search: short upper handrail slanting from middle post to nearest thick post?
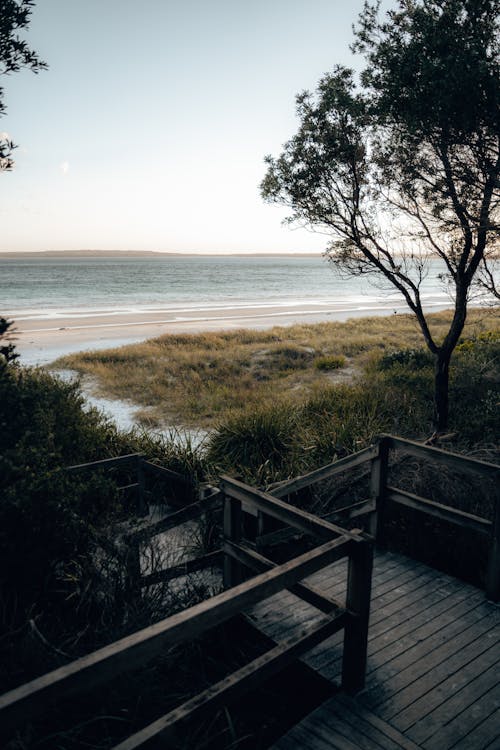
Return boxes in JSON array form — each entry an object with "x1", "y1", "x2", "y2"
[{"x1": 221, "y1": 475, "x2": 360, "y2": 541}]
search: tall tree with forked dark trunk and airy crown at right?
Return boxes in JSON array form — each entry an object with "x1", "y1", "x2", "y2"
[{"x1": 261, "y1": 0, "x2": 500, "y2": 433}]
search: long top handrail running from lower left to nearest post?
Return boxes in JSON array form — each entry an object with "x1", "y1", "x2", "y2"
[{"x1": 0, "y1": 535, "x2": 353, "y2": 728}]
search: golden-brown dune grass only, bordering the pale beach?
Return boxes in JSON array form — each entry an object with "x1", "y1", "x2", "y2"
[{"x1": 55, "y1": 310, "x2": 500, "y2": 428}]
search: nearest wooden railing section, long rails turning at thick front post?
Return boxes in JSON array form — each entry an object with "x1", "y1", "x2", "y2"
[{"x1": 0, "y1": 468, "x2": 373, "y2": 750}]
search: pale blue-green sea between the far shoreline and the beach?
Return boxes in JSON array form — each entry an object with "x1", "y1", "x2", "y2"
[{"x1": 0, "y1": 254, "x2": 450, "y2": 330}]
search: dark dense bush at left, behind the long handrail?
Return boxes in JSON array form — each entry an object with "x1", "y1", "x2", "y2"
[{"x1": 0, "y1": 357, "x2": 209, "y2": 691}]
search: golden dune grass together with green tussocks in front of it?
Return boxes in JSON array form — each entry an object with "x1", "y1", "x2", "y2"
[{"x1": 56, "y1": 309, "x2": 499, "y2": 483}]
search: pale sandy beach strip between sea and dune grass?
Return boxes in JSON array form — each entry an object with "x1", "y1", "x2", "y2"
[{"x1": 14, "y1": 301, "x2": 418, "y2": 365}]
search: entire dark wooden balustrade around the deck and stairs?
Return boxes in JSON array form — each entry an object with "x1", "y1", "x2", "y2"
[{"x1": 0, "y1": 435, "x2": 500, "y2": 750}]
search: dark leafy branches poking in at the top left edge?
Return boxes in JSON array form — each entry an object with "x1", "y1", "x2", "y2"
[{"x1": 0, "y1": 0, "x2": 47, "y2": 170}]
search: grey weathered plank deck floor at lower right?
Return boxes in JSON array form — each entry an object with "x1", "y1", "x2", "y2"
[{"x1": 251, "y1": 552, "x2": 500, "y2": 750}]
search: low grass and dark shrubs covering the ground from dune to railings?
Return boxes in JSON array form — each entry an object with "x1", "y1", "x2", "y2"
[{"x1": 0, "y1": 309, "x2": 500, "y2": 696}]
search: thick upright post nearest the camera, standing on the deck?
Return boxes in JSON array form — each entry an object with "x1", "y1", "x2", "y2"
[{"x1": 342, "y1": 538, "x2": 374, "y2": 693}]
